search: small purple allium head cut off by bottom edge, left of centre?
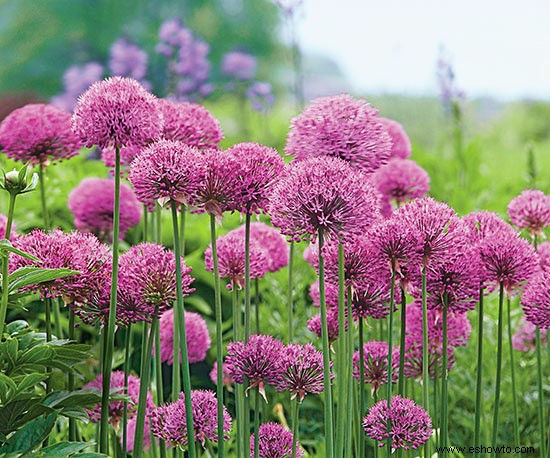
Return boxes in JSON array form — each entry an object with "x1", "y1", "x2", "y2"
[{"x1": 250, "y1": 422, "x2": 304, "y2": 458}]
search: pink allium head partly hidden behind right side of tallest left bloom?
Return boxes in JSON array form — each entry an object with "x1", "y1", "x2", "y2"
[{"x1": 159, "y1": 99, "x2": 223, "y2": 149}]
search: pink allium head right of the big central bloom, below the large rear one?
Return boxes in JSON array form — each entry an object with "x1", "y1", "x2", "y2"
[{"x1": 370, "y1": 159, "x2": 430, "y2": 207}]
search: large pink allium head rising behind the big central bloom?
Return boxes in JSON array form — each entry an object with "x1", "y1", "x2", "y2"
[{"x1": 285, "y1": 94, "x2": 392, "y2": 174}]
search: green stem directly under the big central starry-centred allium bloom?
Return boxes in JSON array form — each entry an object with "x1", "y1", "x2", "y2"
[{"x1": 318, "y1": 228, "x2": 334, "y2": 458}]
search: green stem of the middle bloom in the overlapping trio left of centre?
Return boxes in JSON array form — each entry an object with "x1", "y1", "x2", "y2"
[{"x1": 210, "y1": 215, "x2": 225, "y2": 457}]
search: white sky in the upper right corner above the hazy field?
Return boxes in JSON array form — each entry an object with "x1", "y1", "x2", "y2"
[{"x1": 298, "y1": 0, "x2": 550, "y2": 99}]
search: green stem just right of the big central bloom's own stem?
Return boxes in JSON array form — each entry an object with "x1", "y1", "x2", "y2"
[{"x1": 335, "y1": 242, "x2": 350, "y2": 456}]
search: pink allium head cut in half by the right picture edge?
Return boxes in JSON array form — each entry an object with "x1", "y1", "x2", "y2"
[{"x1": 521, "y1": 271, "x2": 550, "y2": 329}]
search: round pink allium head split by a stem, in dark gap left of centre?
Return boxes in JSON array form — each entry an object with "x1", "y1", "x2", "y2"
[{"x1": 160, "y1": 309, "x2": 211, "y2": 366}]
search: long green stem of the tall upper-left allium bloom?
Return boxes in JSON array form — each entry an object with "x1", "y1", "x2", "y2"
[{"x1": 99, "y1": 145, "x2": 120, "y2": 454}]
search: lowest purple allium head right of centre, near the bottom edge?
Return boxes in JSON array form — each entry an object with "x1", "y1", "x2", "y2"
[{"x1": 363, "y1": 395, "x2": 432, "y2": 450}]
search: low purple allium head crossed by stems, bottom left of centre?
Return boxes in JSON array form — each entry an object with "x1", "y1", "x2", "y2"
[{"x1": 150, "y1": 390, "x2": 231, "y2": 448}]
